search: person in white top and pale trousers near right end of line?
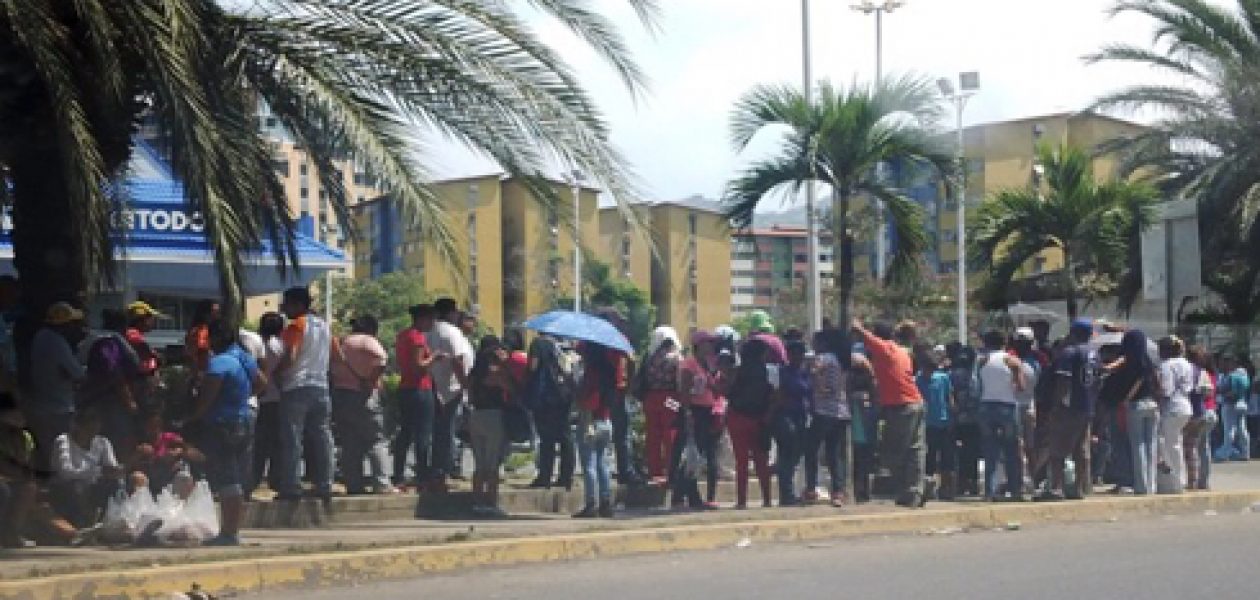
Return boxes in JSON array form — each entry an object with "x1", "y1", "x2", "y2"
[{"x1": 1157, "y1": 337, "x2": 1197, "y2": 494}]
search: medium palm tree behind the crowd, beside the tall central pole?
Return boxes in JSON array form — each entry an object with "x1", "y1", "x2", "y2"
[{"x1": 723, "y1": 77, "x2": 953, "y2": 323}]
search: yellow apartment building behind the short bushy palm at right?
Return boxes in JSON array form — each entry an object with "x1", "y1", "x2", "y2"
[{"x1": 936, "y1": 112, "x2": 1144, "y2": 275}]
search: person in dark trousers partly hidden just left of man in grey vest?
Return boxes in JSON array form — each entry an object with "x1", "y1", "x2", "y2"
[{"x1": 244, "y1": 313, "x2": 285, "y2": 499}]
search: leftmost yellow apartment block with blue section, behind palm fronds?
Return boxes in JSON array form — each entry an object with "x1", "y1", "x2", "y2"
[{"x1": 353, "y1": 174, "x2": 504, "y2": 332}]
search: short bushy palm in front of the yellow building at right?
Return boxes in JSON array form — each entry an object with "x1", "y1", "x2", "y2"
[{"x1": 968, "y1": 144, "x2": 1157, "y2": 319}]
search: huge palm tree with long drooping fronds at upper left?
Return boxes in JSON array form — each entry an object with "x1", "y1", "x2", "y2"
[{"x1": 0, "y1": 0, "x2": 656, "y2": 309}]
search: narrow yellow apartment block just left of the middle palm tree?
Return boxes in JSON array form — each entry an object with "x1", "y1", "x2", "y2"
[{"x1": 651, "y1": 198, "x2": 731, "y2": 335}]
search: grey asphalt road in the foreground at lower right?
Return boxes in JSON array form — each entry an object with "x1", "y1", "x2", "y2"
[{"x1": 252, "y1": 513, "x2": 1260, "y2": 600}]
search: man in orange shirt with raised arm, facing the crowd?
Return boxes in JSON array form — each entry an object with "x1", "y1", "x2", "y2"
[{"x1": 853, "y1": 319, "x2": 927, "y2": 508}]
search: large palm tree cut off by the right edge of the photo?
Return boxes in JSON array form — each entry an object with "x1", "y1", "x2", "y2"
[{"x1": 1087, "y1": 0, "x2": 1260, "y2": 324}]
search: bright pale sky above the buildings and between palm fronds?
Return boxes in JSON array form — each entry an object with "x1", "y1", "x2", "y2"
[{"x1": 440, "y1": 0, "x2": 1189, "y2": 206}]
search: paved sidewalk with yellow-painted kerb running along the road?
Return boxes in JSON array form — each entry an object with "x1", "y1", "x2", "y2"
[{"x1": 7, "y1": 464, "x2": 1260, "y2": 599}]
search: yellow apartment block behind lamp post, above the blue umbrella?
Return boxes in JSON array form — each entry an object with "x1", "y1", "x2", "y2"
[{"x1": 501, "y1": 178, "x2": 600, "y2": 323}]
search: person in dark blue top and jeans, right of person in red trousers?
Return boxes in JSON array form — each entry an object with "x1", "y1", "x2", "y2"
[{"x1": 770, "y1": 340, "x2": 816, "y2": 507}]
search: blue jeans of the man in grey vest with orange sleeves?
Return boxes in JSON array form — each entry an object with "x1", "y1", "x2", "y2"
[{"x1": 280, "y1": 386, "x2": 333, "y2": 498}]
